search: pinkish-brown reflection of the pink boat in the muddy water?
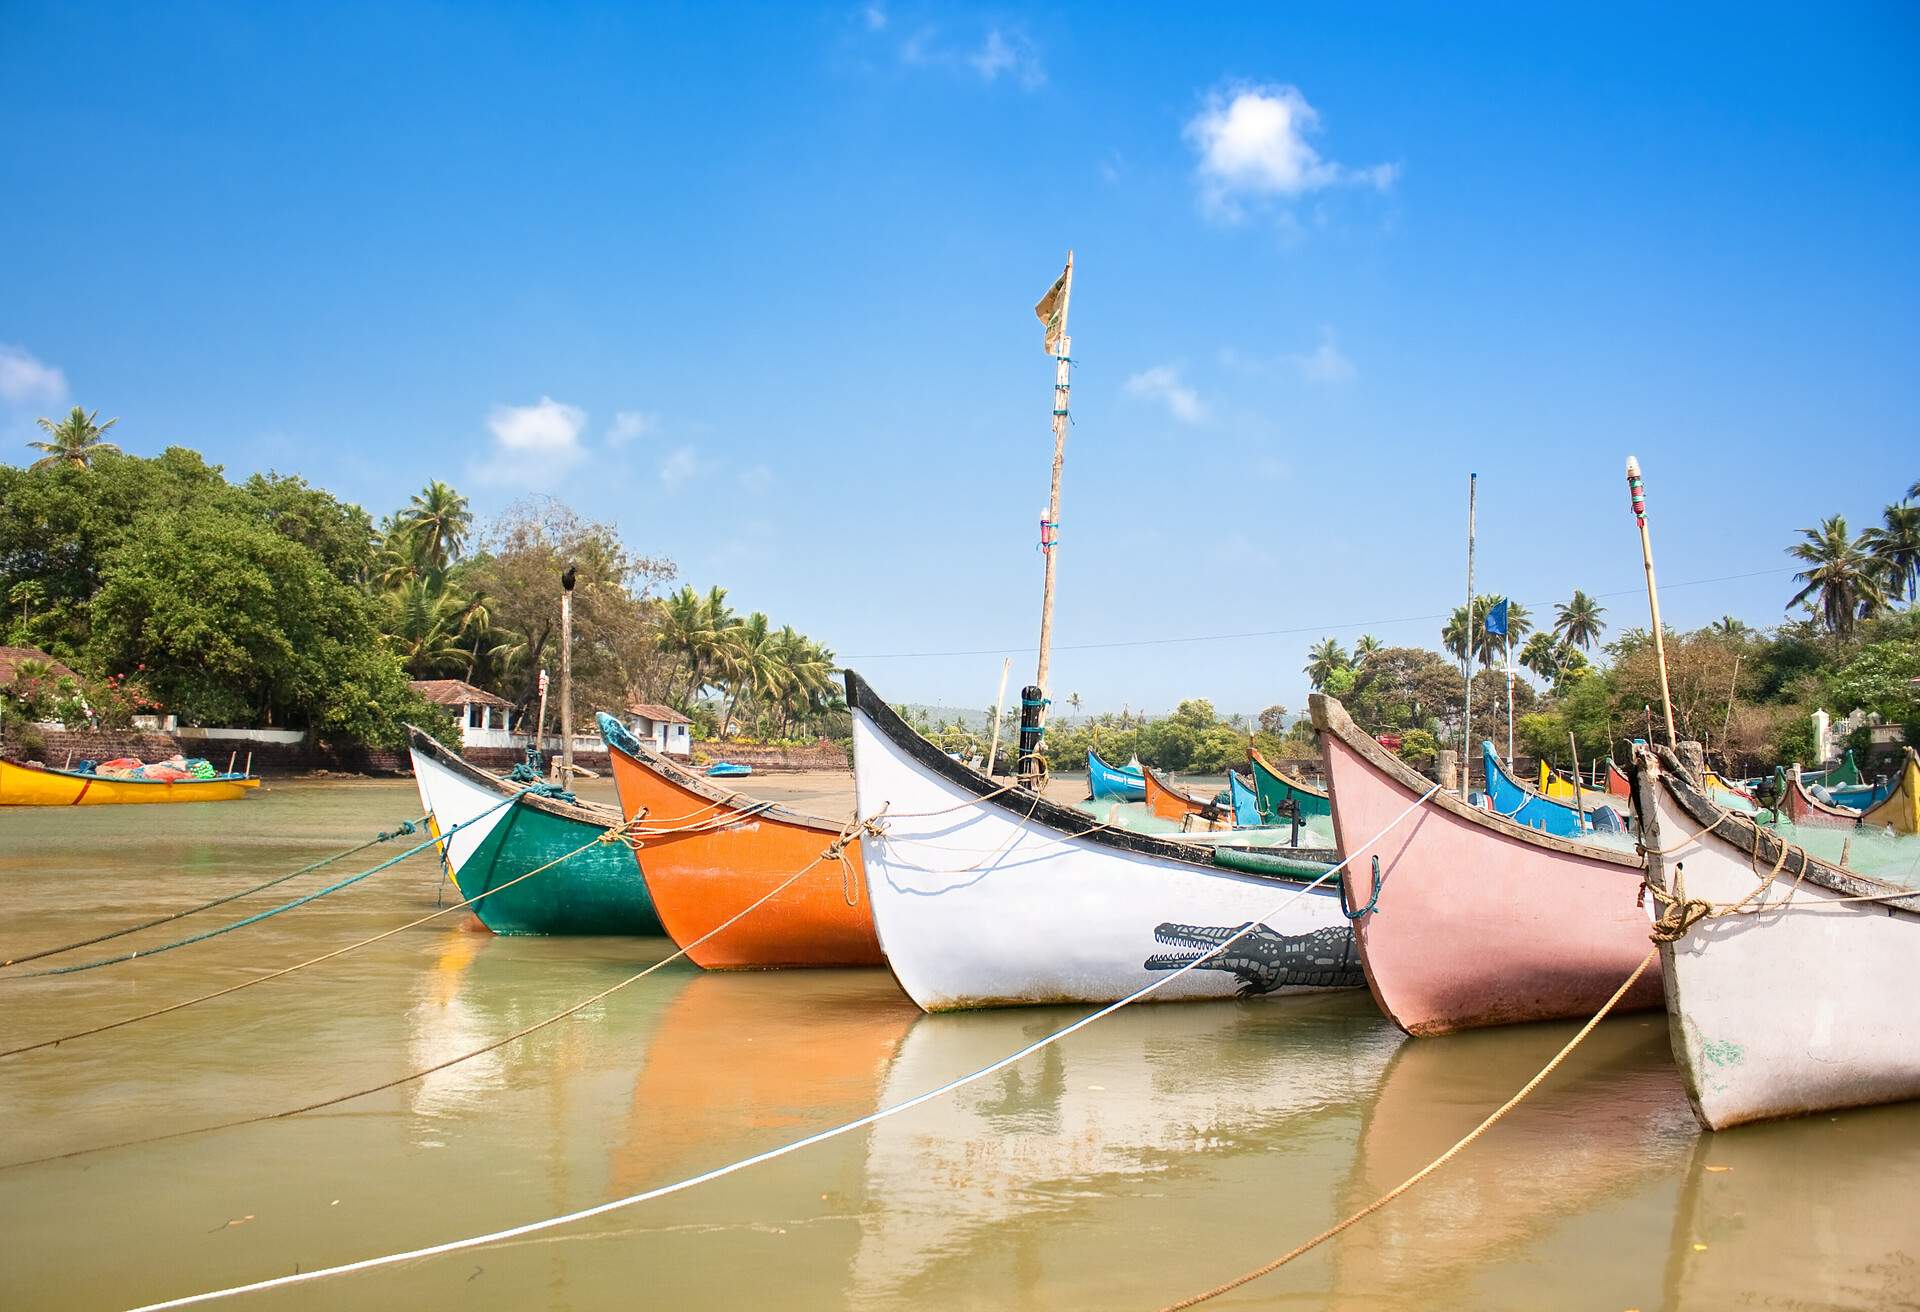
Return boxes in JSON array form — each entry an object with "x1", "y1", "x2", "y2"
[{"x1": 1328, "y1": 1016, "x2": 1695, "y2": 1308}]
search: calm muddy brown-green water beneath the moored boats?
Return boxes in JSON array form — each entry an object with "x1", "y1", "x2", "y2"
[{"x1": 0, "y1": 780, "x2": 1920, "y2": 1310}]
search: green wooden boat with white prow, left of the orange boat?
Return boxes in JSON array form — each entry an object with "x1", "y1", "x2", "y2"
[{"x1": 407, "y1": 724, "x2": 660, "y2": 935}]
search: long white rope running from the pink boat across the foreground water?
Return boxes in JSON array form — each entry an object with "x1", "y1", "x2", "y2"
[{"x1": 123, "y1": 784, "x2": 1443, "y2": 1312}]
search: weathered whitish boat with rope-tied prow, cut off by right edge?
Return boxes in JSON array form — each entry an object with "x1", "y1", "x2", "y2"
[{"x1": 1634, "y1": 747, "x2": 1920, "y2": 1130}]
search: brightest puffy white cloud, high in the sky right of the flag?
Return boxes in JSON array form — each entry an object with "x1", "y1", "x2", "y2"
[{"x1": 1187, "y1": 85, "x2": 1398, "y2": 219}]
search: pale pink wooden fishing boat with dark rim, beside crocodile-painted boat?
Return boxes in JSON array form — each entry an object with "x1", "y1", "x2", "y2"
[{"x1": 1309, "y1": 693, "x2": 1663, "y2": 1035}]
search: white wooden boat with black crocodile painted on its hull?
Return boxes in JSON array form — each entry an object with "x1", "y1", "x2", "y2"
[{"x1": 847, "y1": 670, "x2": 1361, "y2": 1012}]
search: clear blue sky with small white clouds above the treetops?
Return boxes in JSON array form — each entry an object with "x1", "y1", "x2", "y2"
[{"x1": 0, "y1": 0, "x2": 1920, "y2": 711}]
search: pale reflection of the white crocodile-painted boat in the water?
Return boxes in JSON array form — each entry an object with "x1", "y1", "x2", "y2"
[{"x1": 847, "y1": 995, "x2": 1402, "y2": 1308}]
